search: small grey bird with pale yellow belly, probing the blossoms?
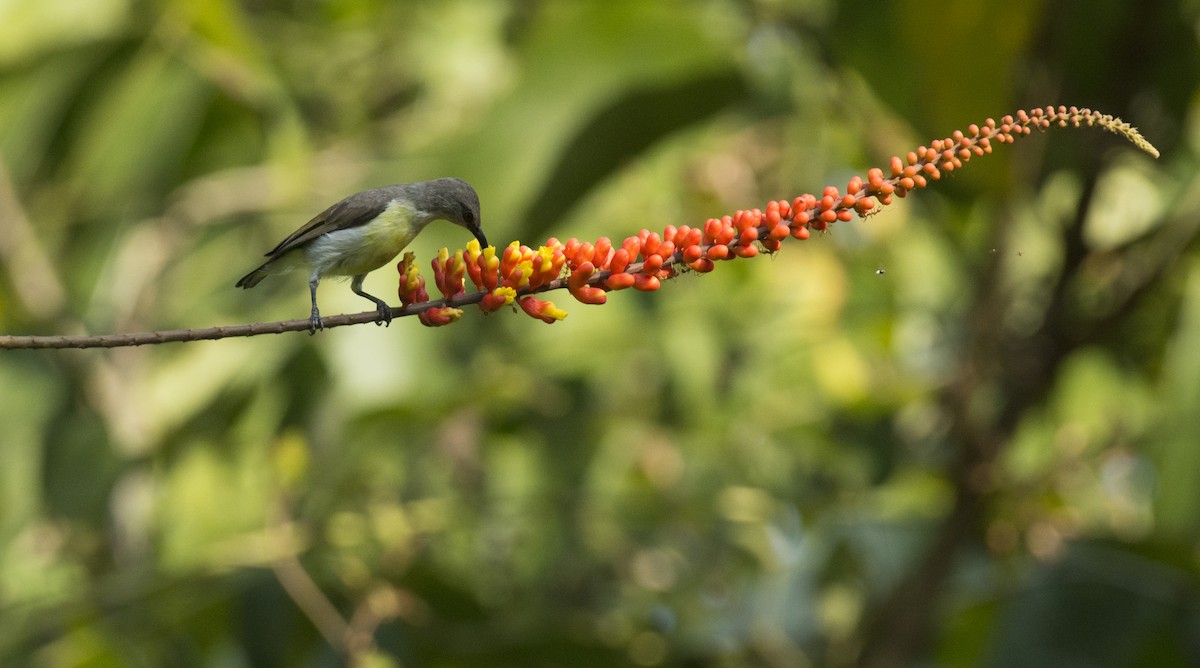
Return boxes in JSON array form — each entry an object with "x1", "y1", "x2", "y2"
[{"x1": 236, "y1": 177, "x2": 487, "y2": 335}]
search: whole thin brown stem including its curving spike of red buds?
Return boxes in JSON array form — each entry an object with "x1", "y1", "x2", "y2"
[{"x1": 0, "y1": 107, "x2": 1158, "y2": 349}]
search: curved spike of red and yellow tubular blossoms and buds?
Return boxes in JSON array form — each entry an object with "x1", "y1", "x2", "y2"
[{"x1": 400, "y1": 107, "x2": 1158, "y2": 325}]
